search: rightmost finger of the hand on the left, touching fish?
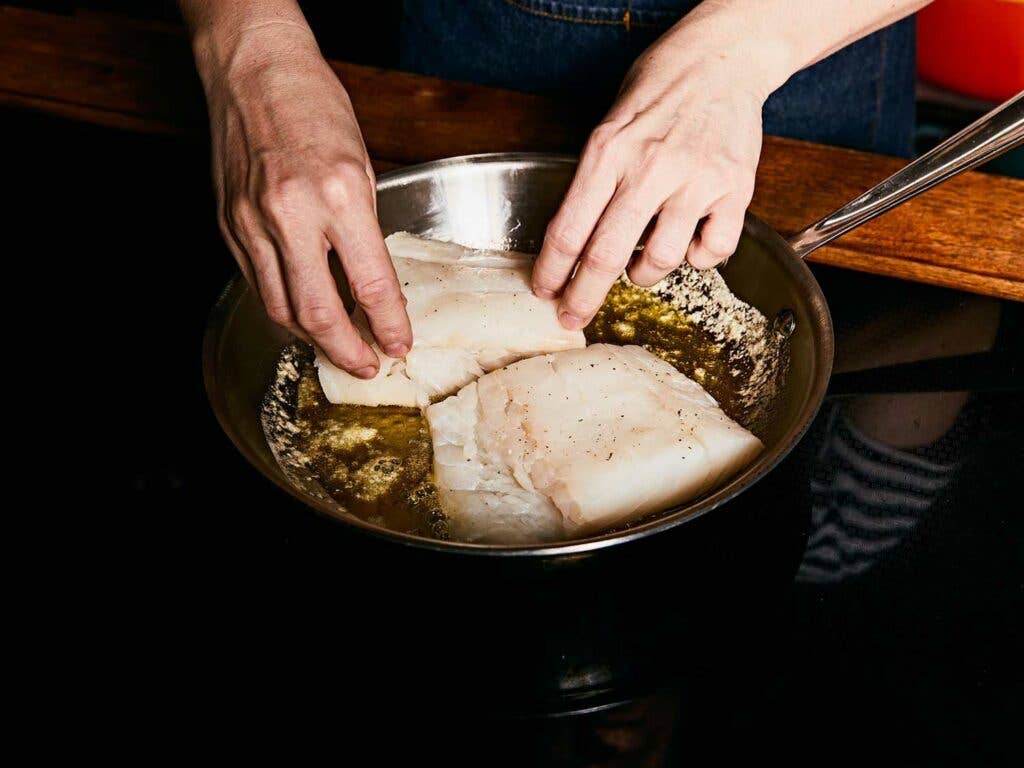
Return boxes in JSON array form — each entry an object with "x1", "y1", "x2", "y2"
[{"x1": 328, "y1": 200, "x2": 413, "y2": 357}]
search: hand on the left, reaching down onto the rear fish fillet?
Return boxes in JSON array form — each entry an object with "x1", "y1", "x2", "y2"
[{"x1": 204, "y1": 32, "x2": 413, "y2": 378}]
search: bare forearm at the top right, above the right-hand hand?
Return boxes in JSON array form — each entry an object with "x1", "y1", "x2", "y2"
[{"x1": 666, "y1": 0, "x2": 930, "y2": 96}]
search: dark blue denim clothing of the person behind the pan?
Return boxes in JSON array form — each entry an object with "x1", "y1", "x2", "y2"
[{"x1": 401, "y1": 0, "x2": 914, "y2": 156}]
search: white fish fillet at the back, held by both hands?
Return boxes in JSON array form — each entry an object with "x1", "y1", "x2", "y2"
[{"x1": 316, "y1": 232, "x2": 586, "y2": 408}]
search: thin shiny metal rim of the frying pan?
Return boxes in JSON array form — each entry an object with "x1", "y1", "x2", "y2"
[{"x1": 203, "y1": 152, "x2": 835, "y2": 559}]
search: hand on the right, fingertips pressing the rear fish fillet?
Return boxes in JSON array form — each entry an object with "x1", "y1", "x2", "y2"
[{"x1": 534, "y1": 25, "x2": 770, "y2": 329}]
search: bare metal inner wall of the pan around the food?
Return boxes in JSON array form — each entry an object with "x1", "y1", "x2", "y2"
[{"x1": 205, "y1": 156, "x2": 831, "y2": 551}]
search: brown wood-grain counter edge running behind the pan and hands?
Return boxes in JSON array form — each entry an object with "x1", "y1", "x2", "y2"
[{"x1": 0, "y1": 5, "x2": 1024, "y2": 300}]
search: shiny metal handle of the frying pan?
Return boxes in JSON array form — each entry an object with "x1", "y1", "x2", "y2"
[{"x1": 790, "y1": 91, "x2": 1024, "y2": 258}]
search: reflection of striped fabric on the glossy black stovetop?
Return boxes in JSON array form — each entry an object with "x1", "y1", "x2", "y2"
[{"x1": 797, "y1": 403, "x2": 964, "y2": 585}]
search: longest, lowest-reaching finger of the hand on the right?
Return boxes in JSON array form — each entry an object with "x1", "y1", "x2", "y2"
[{"x1": 558, "y1": 187, "x2": 657, "y2": 330}]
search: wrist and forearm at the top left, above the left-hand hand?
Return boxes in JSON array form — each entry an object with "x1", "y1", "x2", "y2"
[{"x1": 179, "y1": 0, "x2": 318, "y2": 89}]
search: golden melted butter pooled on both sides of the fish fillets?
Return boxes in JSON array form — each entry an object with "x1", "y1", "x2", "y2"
[{"x1": 294, "y1": 283, "x2": 744, "y2": 539}]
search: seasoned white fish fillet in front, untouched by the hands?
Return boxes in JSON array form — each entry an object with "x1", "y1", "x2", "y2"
[{"x1": 426, "y1": 344, "x2": 763, "y2": 544}]
